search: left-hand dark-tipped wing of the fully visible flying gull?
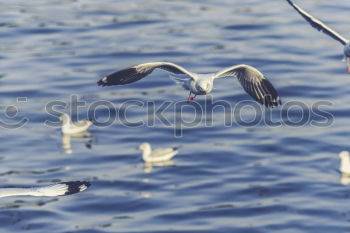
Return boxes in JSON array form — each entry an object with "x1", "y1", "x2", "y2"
[{"x1": 97, "y1": 62, "x2": 197, "y2": 86}]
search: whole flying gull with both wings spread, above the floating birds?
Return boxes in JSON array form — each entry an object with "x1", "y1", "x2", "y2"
[{"x1": 97, "y1": 62, "x2": 281, "y2": 107}]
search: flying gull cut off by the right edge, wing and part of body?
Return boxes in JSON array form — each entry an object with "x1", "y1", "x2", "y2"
[{"x1": 287, "y1": 0, "x2": 350, "y2": 73}]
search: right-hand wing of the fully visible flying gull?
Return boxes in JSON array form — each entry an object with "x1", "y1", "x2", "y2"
[{"x1": 214, "y1": 65, "x2": 281, "y2": 107}]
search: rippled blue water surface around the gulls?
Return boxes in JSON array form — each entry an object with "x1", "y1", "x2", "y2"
[{"x1": 0, "y1": 0, "x2": 350, "y2": 232}]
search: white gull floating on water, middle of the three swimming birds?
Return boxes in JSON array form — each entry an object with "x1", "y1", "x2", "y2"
[{"x1": 138, "y1": 142, "x2": 179, "y2": 163}]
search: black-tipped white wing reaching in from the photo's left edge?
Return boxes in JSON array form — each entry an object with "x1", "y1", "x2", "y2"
[{"x1": 0, "y1": 181, "x2": 91, "y2": 197}]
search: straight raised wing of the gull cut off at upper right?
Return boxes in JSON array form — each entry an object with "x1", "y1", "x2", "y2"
[{"x1": 287, "y1": 0, "x2": 348, "y2": 45}]
